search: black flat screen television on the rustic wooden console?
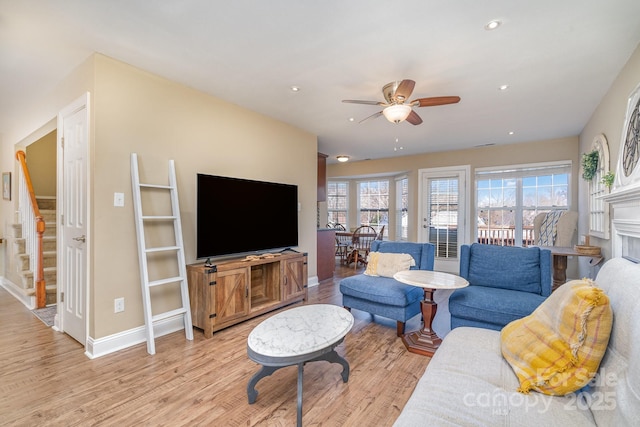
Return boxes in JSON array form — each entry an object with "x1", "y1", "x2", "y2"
[{"x1": 196, "y1": 173, "x2": 298, "y2": 258}]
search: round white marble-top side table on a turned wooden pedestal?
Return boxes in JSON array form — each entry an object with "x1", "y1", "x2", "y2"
[{"x1": 393, "y1": 270, "x2": 469, "y2": 356}]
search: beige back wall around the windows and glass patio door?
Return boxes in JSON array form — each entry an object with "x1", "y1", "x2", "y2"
[{"x1": 327, "y1": 137, "x2": 579, "y2": 241}]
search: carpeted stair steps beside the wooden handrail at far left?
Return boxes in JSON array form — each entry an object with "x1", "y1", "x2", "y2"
[{"x1": 13, "y1": 196, "x2": 57, "y2": 305}]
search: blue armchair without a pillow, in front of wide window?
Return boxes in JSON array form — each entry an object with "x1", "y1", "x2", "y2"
[{"x1": 449, "y1": 243, "x2": 551, "y2": 331}]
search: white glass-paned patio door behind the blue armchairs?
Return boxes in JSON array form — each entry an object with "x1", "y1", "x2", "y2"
[{"x1": 418, "y1": 166, "x2": 469, "y2": 274}]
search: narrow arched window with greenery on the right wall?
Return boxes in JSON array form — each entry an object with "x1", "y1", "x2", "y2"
[{"x1": 589, "y1": 134, "x2": 609, "y2": 239}]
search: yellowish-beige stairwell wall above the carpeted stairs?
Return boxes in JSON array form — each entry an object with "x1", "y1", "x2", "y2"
[{"x1": 26, "y1": 131, "x2": 57, "y2": 196}]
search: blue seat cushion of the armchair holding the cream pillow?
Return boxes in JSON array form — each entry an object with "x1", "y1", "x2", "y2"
[{"x1": 340, "y1": 274, "x2": 424, "y2": 307}]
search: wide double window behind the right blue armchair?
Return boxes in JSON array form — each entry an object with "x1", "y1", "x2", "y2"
[{"x1": 476, "y1": 162, "x2": 571, "y2": 246}]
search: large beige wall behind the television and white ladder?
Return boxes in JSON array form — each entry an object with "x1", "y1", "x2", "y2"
[{"x1": 2, "y1": 54, "x2": 317, "y2": 339}]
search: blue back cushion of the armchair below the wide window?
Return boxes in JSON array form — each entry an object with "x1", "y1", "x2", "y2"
[{"x1": 461, "y1": 244, "x2": 542, "y2": 295}]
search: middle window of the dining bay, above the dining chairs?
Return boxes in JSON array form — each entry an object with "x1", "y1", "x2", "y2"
[{"x1": 358, "y1": 180, "x2": 389, "y2": 231}]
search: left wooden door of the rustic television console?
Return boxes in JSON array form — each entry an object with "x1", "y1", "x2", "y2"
[{"x1": 212, "y1": 268, "x2": 250, "y2": 326}]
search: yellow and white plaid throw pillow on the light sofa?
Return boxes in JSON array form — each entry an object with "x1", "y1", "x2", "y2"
[{"x1": 500, "y1": 279, "x2": 613, "y2": 395}]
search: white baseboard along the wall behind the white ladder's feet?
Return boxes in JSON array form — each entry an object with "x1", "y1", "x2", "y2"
[{"x1": 84, "y1": 315, "x2": 184, "y2": 359}]
